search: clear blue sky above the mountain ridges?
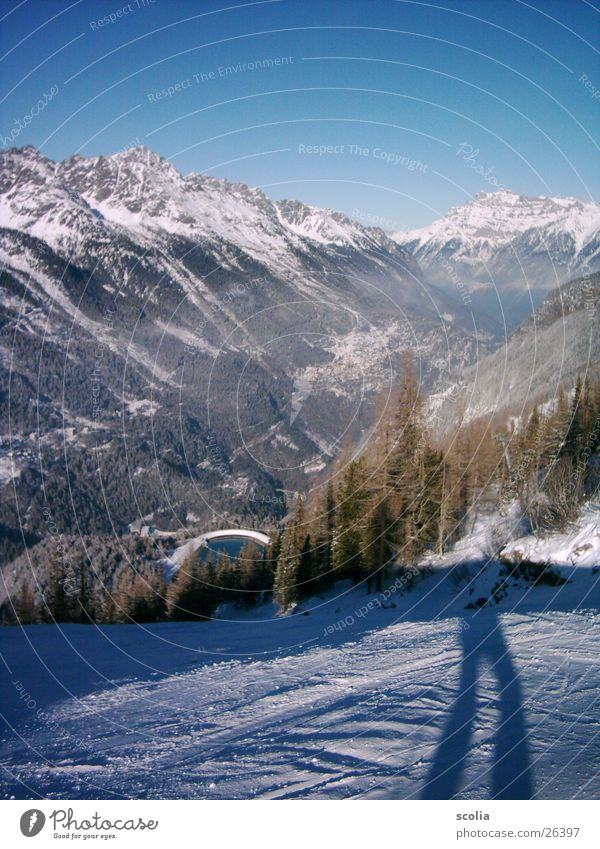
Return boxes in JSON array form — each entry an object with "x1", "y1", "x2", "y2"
[{"x1": 0, "y1": 0, "x2": 600, "y2": 229}]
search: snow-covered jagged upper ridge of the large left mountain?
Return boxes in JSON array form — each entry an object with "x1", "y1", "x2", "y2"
[{"x1": 0, "y1": 147, "x2": 414, "y2": 274}]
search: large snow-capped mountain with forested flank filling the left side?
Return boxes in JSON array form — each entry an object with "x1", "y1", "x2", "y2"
[{"x1": 0, "y1": 147, "x2": 496, "y2": 547}]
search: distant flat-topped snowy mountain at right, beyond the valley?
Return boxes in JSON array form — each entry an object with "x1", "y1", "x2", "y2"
[{"x1": 392, "y1": 190, "x2": 600, "y2": 330}]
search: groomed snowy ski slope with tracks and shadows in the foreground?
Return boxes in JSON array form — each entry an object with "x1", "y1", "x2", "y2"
[{"x1": 0, "y1": 504, "x2": 600, "y2": 799}]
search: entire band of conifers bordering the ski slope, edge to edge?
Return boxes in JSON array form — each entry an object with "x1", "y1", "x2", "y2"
[{"x1": 2, "y1": 357, "x2": 600, "y2": 623}]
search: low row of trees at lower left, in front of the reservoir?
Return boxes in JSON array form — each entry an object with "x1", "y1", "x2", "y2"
[{"x1": 0, "y1": 535, "x2": 277, "y2": 625}]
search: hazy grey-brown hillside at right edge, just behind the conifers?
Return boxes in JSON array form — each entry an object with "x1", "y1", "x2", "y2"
[{"x1": 430, "y1": 272, "x2": 600, "y2": 430}]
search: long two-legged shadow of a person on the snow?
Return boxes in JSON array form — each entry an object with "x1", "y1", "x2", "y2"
[{"x1": 421, "y1": 610, "x2": 533, "y2": 799}]
